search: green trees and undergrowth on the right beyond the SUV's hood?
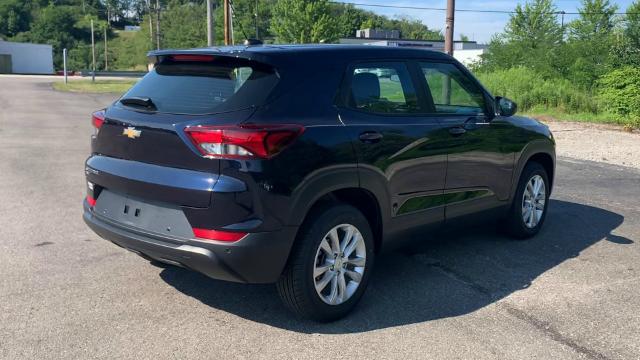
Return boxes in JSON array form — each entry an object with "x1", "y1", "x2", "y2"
[{"x1": 473, "y1": 0, "x2": 640, "y2": 126}]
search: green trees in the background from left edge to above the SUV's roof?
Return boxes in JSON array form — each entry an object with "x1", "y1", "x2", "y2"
[{"x1": 0, "y1": 0, "x2": 443, "y2": 70}]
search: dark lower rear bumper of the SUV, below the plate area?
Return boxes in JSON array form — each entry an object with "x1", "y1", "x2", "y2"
[{"x1": 83, "y1": 201, "x2": 297, "y2": 283}]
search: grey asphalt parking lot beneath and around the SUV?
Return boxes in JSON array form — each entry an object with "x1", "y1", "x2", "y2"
[{"x1": 0, "y1": 77, "x2": 640, "y2": 359}]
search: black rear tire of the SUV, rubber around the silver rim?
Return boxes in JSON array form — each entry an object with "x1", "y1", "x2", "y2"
[{"x1": 277, "y1": 204, "x2": 374, "y2": 322}]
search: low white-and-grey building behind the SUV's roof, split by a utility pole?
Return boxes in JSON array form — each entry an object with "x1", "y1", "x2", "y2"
[{"x1": 340, "y1": 29, "x2": 487, "y2": 65}]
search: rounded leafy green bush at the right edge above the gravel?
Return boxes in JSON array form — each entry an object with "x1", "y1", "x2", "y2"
[{"x1": 598, "y1": 66, "x2": 640, "y2": 122}]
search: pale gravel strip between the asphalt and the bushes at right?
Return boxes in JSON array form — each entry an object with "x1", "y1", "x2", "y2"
[{"x1": 544, "y1": 121, "x2": 640, "y2": 169}]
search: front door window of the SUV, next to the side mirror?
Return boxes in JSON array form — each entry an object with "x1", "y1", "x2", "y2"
[{"x1": 420, "y1": 63, "x2": 485, "y2": 115}]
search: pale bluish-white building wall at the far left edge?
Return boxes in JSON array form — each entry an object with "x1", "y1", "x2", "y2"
[{"x1": 0, "y1": 40, "x2": 53, "y2": 74}]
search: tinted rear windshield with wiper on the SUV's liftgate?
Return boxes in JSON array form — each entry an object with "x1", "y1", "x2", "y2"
[{"x1": 118, "y1": 57, "x2": 278, "y2": 115}]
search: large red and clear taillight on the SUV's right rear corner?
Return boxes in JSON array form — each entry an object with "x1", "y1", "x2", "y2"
[{"x1": 184, "y1": 125, "x2": 304, "y2": 159}]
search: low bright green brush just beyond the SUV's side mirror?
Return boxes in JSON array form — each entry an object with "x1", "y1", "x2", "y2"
[{"x1": 476, "y1": 67, "x2": 599, "y2": 113}]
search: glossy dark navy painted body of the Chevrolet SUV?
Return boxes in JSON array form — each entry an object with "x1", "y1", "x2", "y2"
[{"x1": 85, "y1": 45, "x2": 555, "y2": 282}]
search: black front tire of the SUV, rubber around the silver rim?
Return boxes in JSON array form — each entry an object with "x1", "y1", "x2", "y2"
[{"x1": 505, "y1": 162, "x2": 550, "y2": 239}]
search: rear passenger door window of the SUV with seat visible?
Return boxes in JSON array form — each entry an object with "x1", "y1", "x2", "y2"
[{"x1": 349, "y1": 63, "x2": 419, "y2": 114}]
